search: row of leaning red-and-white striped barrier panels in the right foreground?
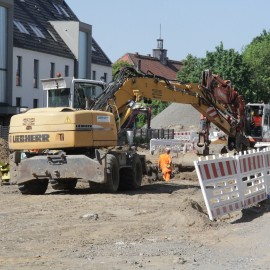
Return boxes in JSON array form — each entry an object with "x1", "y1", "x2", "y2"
[{"x1": 194, "y1": 150, "x2": 270, "y2": 220}]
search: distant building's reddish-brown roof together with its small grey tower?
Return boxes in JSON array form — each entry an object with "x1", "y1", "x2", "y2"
[{"x1": 117, "y1": 38, "x2": 182, "y2": 80}]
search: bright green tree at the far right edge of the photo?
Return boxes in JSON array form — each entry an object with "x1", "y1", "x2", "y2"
[{"x1": 243, "y1": 30, "x2": 270, "y2": 103}]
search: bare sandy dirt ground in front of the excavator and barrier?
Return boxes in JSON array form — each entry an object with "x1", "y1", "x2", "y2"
[{"x1": 0, "y1": 142, "x2": 270, "y2": 270}]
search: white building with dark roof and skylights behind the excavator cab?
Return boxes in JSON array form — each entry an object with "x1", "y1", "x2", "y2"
[{"x1": 0, "y1": 0, "x2": 112, "y2": 125}]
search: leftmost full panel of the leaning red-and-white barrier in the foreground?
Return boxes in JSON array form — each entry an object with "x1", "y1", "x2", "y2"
[{"x1": 194, "y1": 156, "x2": 243, "y2": 220}]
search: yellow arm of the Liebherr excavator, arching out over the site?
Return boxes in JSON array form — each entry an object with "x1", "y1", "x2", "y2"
[{"x1": 93, "y1": 68, "x2": 244, "y2": 151}]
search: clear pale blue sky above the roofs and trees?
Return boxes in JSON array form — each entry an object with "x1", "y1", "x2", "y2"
[{"x1": 66, "y1": 0, "x2": 270, "y2": 62}]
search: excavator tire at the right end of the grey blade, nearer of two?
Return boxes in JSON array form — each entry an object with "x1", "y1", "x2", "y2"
[{"x1": 104, "y1": 154, "x2": 119, "y2": 193}]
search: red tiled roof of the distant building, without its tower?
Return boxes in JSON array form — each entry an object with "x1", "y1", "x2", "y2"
[{"x1": 117, "y1": 53, "x2": 182, "y2": 80}]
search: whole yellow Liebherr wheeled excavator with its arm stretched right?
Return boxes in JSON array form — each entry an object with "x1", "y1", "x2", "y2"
[{"x1": 9, "y1": 68, "x2": 248, "y2": 194}]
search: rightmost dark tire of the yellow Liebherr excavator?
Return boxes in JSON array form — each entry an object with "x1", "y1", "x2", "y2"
[{"x1": 120, "y1": 154, "x2": 143, "y2": 190}]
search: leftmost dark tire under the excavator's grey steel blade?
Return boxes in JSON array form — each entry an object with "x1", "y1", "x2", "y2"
[{"x1": 18, "y1": 179, "x2": 49, "y2": 195}]
